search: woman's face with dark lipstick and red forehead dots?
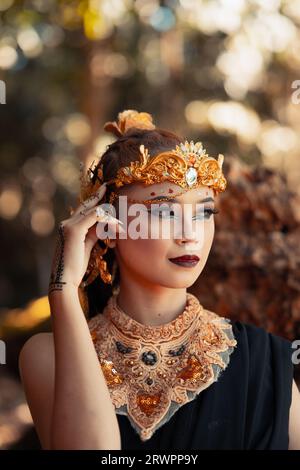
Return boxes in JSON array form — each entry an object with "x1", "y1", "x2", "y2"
[{"x1": 111, "y1": 182, "x2": 215, "y2": 288}]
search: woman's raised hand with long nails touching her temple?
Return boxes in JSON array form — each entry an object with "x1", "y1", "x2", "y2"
[{"x1": 48, "y1": 183, "x2": 123, "y2": 294}]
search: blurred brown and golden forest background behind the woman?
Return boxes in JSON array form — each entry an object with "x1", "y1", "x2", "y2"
[{"x1": 0, "y1": 0, "x2": 300, "y2": 449}]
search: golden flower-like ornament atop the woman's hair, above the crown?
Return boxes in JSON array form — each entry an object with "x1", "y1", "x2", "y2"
[{"x1": 103, "y1": 109, "x2": 155, "y2": 137}]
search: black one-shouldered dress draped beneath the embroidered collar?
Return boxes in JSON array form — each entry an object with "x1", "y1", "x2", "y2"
[{"x1": 117, "y1": 321, "x2": 294, "y2": 450}]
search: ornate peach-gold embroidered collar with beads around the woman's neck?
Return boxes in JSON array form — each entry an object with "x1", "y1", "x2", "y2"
[{"x1": 88, "y1": 293, "x2": 237, "y2": 441}]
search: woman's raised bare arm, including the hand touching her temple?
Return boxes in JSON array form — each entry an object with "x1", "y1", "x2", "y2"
[{"x1": 44, "y1": 185, "x2": 121, "y2": 449}]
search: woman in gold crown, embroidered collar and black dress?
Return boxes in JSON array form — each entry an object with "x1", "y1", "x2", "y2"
[{"x1": 19, "y1": 110, "x2": 300, "y2": 450}]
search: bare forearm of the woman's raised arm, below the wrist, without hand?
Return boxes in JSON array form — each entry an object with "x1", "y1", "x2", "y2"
[{"x1": 50, "y1": 285, "x2": 121, "y2": 449}]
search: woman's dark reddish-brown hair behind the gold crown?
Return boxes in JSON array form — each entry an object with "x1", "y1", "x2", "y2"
[{"x1": 86, "y1": 127, "x2": 183, "y2": 318}]
